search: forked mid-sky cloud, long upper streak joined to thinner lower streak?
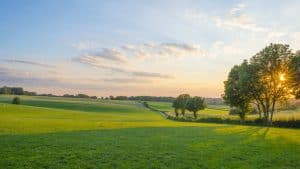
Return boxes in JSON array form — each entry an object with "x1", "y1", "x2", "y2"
[{"x1": 73, "y1": 43, "x2": 204, "y2": 79}]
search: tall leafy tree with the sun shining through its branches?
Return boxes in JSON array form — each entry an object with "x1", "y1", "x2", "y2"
[{"x1": 250, "y1": 44, "x2": 295, "y2": 125}]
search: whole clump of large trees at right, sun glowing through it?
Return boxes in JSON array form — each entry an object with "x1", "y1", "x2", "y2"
[{"x1": 223, "y1": 44, "x2": 300, "y2": 125}]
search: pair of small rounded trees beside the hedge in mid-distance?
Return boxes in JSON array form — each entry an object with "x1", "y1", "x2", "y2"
[{"x1": 172, "y1": 94, "x2": 206, "y2": 119}]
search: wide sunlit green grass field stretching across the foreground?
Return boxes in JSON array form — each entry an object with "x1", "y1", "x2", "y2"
[{"x1": 0, "y1": 96, "x2": 300, "y2": 169}]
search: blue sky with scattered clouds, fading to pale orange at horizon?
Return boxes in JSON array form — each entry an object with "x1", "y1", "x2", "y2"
[{"x1": 0, "y1": 0, "x2": 300, "y2": 97}]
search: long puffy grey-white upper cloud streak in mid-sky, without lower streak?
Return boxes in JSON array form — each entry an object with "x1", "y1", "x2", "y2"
[{"x1": 77, "y1": 43, "x2": 204, "y2": 63}]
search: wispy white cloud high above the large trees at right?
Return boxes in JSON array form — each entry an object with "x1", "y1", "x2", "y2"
[{"x1": 213, "y1": 4, "x2": 266, "y2": 32}]
